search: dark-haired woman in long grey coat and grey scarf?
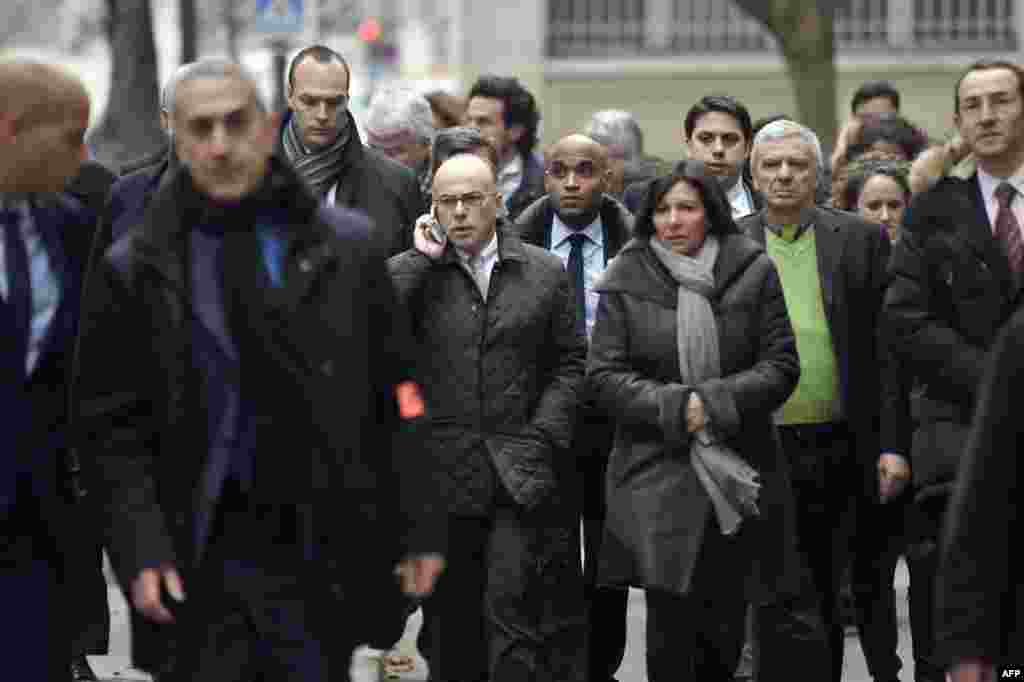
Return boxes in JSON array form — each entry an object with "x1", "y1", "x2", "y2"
[{"x1": 588, "y1": 161, "x2": 800, "y2": 682}]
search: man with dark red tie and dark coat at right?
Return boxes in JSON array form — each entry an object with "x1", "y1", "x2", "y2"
[{"x1": 886, "y1": 60, "x2": 1024, "y2": 682}]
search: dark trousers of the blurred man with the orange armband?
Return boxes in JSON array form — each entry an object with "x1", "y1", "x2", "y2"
[{"x1": 160, "y1": 481, "x2": 346, "y2": 682}]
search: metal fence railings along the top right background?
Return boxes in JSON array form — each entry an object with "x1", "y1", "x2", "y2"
[{"x1": 548, "y1": 0, "x2": 1018, "y2": 58}]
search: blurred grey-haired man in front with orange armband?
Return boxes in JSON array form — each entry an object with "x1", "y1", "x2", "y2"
[{"x1": 76, "y1": 59, "x2": 444, "y2": 682}]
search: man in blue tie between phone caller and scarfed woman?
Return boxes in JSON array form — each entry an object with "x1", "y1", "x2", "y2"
[{"x1": 516, "y1": 135, "x2": 633, "y2": 682}]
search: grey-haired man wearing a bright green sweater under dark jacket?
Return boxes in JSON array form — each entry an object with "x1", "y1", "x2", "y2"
[{"x1": 739, "y1": 121, "x2": 905, "y2": 682}]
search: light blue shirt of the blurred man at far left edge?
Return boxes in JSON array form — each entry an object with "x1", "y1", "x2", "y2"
[{"x1": 0, "y1": 200, "x2": 60, "y2": 374}]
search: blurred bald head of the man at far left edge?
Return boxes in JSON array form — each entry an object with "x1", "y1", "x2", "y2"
[{"x1": 0, "y1": 59, "x2": 89, "y2": 194}]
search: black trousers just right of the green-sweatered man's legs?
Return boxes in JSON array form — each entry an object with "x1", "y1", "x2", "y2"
[{"x1": 852, "y1": 485, "x2": 945, "y2": 682}]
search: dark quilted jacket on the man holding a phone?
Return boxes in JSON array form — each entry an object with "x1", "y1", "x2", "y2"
[{"x1": 388, "y1": 221, "x2": 586, "y2": 516}]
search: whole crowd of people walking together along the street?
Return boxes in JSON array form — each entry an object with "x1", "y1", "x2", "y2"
[{"x1": 0, "y1": 45, "x2": 1024, "y2": 682}]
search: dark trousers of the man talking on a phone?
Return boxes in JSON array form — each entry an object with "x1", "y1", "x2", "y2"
[{"x1": 418, "y1": 503, "x2": 586, "y2": 682}]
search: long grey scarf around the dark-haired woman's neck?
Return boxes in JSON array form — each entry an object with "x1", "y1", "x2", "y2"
[{"x1": 650, "y1": 235, "x2": 761, "y2": 536}]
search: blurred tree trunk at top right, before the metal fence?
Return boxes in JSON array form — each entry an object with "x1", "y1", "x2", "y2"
[{"x1": 736, "y1": 0, "x2": 844, "y2": 148}]
